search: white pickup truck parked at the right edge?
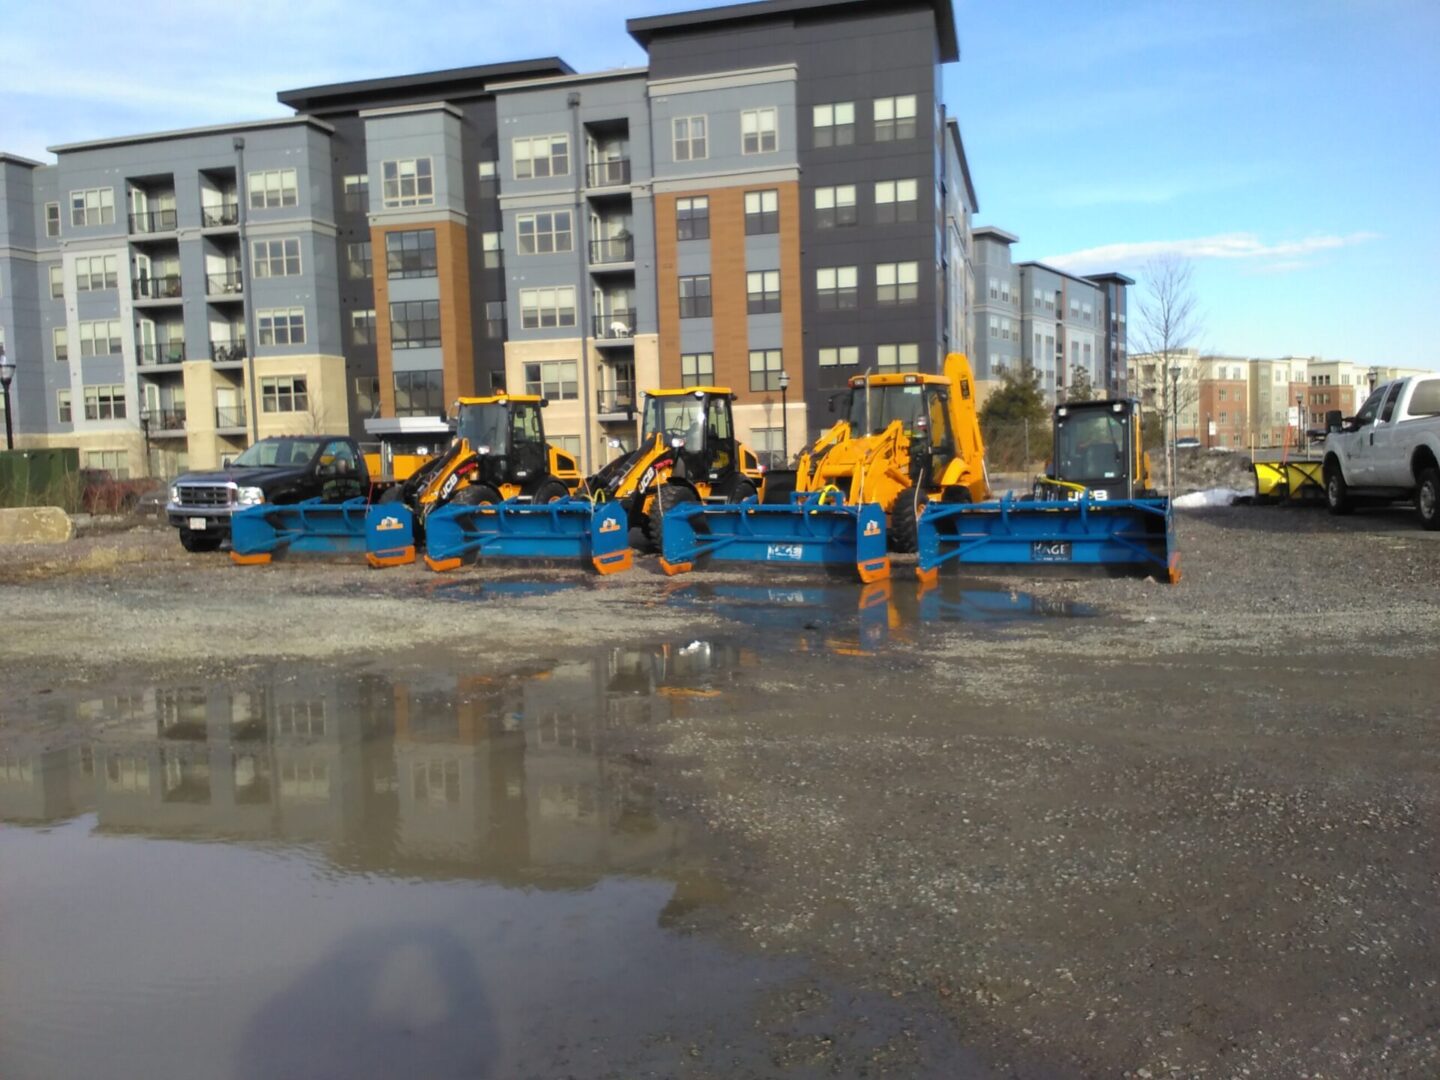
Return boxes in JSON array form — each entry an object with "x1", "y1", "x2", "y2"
[{"x1": 1323, "y1": 374, "x2": 1440, "y2": 528}]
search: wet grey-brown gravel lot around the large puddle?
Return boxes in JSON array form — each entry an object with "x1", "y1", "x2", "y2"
[{"x1": 0, "y1": 507, "x2": 1440, "y2": 1077}]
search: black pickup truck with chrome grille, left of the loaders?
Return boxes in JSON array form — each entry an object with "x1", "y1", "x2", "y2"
[{"x1": 166, "y1": 435, "x2": 370, "y2": 552}]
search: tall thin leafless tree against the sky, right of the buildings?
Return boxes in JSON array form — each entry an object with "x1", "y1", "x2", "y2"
[{"x1": 1133, "y1": 255, "x2": 1200, "y2": 492}]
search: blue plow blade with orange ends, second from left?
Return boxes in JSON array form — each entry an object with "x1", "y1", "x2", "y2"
[{"x1": 425, "y1": 498, "x2": 632, "y2": 575}]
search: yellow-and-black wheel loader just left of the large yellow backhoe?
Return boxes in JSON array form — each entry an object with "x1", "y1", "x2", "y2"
[{"x1": 585, "y1": 386, "x2": 765, "y2": 550}]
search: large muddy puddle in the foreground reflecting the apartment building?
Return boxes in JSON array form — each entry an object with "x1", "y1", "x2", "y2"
[{"x1": 0, "y1": 639, "x2": 984, "y2": 1080}]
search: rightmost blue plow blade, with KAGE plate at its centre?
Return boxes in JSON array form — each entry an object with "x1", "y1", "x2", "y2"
[{"x1": 916, "y1": 495, "x2": 1179, "y2": 585}]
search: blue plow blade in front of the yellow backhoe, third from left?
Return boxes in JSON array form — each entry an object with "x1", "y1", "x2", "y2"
[{"x1": 660, "y1": 492, "x2": 890, "y2": 583}]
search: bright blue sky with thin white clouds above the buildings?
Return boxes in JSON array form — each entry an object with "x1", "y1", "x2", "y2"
[{"x1": 0, "y1": 0, "x2": 1440, "y2": 367}]
